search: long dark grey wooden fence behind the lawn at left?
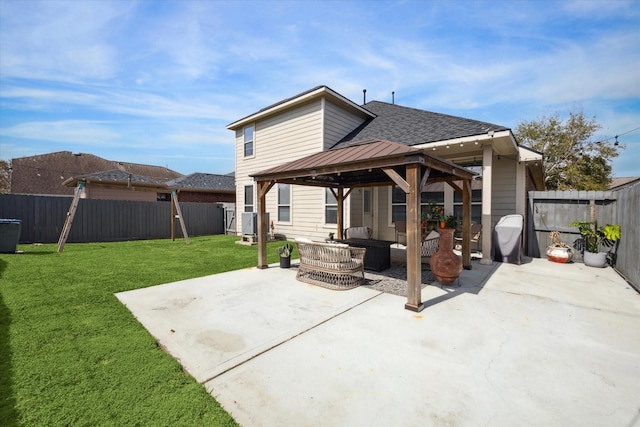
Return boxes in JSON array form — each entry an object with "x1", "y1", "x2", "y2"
[{"x1": 0, "y1": 194, "x2": 224, "y2": 243}]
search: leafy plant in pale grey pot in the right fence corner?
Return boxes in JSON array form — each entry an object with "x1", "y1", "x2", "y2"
[{"x1": 570, "y1": 221, "x2": 621, "y2": 267}]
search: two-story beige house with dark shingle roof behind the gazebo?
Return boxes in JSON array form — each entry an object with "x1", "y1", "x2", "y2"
[{"x1": 227, "y1": 86, "x2": 543, "y2": 263}]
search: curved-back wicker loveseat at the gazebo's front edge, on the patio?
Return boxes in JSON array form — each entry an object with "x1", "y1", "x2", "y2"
[{"x1": 295, "y1": 239, "x2": 366, "y2": 290}]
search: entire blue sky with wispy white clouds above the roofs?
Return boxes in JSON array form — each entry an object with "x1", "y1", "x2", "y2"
[{"x1": 0, "y1": 0, "x2": 640, "y2": 176}]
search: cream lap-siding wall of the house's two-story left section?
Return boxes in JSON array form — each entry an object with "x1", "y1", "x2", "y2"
[{"x1": 236, "y1": 99, "x2": 363, "y2": 240}]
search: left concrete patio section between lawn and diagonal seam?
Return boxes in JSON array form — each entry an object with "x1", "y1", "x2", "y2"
[{"x1": 116, "y1": 268, "x2": 379, "y2": 382}]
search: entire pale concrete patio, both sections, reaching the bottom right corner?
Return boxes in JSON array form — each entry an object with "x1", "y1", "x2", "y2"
[{"x1": 118, "y1": 259, "x2": 640, "y2": 427}]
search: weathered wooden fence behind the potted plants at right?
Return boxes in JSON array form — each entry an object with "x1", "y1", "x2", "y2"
[{"x1": 527, "y1": 184, "x2": 640, "y2": 289}]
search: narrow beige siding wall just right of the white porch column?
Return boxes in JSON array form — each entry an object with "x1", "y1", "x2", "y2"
[{"x1": 491, "y1": 155, "x2": 517, "y2": 225}]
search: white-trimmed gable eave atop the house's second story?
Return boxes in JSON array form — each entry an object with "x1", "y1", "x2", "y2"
[{"x1": 227, "y1": 86, "x2": 374, "y2": 130}]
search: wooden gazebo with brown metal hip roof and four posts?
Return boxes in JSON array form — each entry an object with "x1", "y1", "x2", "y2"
[{"x1": 251, "y1": 140, "x2": 475, "y2": 311}]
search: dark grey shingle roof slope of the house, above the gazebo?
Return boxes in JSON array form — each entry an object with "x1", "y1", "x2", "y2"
[{"x1": 332, "y1": 101, "x2": 509, "y2": 148}]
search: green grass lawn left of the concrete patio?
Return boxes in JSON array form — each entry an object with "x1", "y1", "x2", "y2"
[{"x1": 0, "y1": 236, "x2": 292, "y2": 426}]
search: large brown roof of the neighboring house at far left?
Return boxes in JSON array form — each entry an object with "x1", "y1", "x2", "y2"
[{"x1": 11, "y1": 151, "x2": 182, "y2": 195}]
